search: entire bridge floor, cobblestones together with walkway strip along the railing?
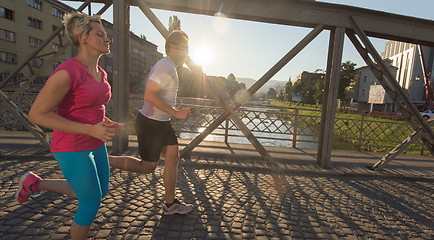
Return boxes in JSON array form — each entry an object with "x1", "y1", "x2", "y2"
[{"x1": 0, "y1": 132, "x2": 434, "y2": 240}]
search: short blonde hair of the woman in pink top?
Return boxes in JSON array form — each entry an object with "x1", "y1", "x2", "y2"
[{"x1": 62, "y1": 12, "x2": 102, "y2": 47}]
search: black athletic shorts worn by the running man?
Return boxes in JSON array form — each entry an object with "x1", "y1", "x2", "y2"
[{"x1": 136, "y1": 112, "x2": 178, "y2": 162}]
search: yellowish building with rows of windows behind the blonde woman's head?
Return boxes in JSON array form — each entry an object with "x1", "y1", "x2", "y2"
[{"x1": 0, "y1": 0, "x2": 75, "y2": 88}]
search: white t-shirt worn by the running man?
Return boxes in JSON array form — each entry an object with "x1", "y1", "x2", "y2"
[{"x1": 139, "y1": 56, "x2": 179, "y2": 121}]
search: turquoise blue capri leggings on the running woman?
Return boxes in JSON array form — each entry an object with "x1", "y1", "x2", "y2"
[{"x1": 53, "y1": 143, "x2": 110, "y2": 226}]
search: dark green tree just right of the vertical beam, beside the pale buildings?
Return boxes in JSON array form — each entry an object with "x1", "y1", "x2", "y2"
[{"x1": 338, "y1": 61, "x2": 357, "y2": 104}]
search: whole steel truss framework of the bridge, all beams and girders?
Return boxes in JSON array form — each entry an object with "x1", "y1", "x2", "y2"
[{"x1": 0, "y1": 0, "x2": 434, "y2": 170}]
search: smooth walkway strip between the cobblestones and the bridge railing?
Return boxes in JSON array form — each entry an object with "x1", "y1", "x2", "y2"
[{"x1": 0, "y1": 131, "x2": 434, "y2": 178}]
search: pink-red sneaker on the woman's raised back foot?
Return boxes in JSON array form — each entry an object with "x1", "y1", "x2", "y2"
[{"x1": 15, "y1": 171, "x2": 42, "y2": 203}]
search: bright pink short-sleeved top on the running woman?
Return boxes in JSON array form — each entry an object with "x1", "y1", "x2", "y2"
[{"x1": 50, "y1": 58, "x2": 111, "y2": 152}]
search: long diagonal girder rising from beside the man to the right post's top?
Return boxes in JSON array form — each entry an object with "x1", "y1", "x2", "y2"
[{"x1": 181, "y1": 25, "x2": 324, "y2": 156}]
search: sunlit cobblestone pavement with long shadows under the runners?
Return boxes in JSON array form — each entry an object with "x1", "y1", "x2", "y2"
[{"x1": 0, "y1": 159, "x2": 434, "y2": 240}]
